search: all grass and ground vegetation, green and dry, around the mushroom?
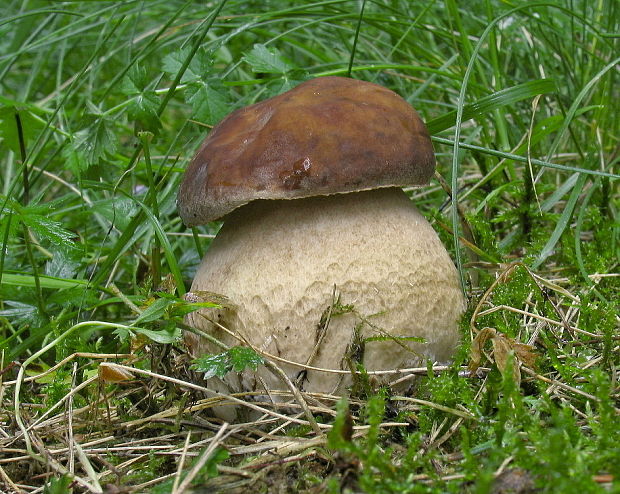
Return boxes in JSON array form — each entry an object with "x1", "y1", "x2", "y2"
[{"x1": 0, "y1": 0, "x2": 620, "y2": 493}]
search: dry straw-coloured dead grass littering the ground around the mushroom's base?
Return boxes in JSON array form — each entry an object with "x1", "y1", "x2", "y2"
[{"x1": 0, "y1": 264, "x2": 620, "y2": 493}]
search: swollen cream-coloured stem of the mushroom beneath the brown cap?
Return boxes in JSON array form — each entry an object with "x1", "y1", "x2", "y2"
[{"x1": 186, "y1": 188, "x2": 464, "y2": 414}]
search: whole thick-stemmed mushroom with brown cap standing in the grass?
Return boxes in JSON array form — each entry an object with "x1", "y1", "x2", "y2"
[{"x1": 178, "y1": 77, "x2": 464, "y2": 416}]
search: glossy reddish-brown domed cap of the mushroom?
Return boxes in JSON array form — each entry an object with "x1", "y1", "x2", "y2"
[{"x1": 178, "y1": 77, "x2": 435, "y2": 226}]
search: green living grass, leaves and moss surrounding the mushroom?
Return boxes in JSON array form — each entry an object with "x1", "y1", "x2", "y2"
[{"x1": 0, "y1": 0, "x2": 620, "y2": 492}]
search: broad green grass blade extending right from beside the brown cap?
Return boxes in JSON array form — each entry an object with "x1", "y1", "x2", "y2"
[{"x1": 426, "y1": 79, "x2": 556, "y2": 135}]
